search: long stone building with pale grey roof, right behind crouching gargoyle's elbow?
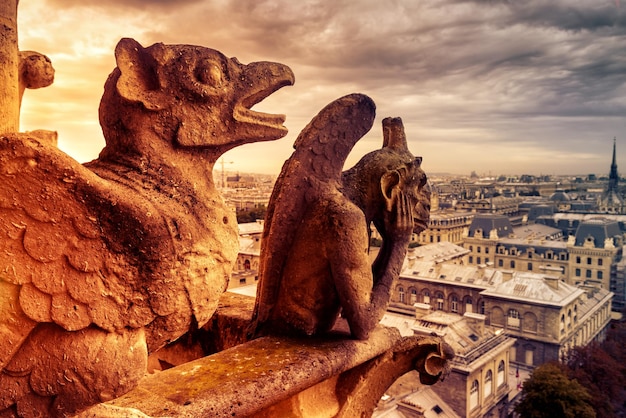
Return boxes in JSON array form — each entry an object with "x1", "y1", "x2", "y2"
[{"x1": 389, "y1": 248, "x2": 613, "y2": 369}]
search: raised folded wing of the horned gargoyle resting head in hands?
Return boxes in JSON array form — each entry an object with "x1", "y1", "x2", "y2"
[{"x1": 253, "y1": 94, "x2": 376, "y2": 332}]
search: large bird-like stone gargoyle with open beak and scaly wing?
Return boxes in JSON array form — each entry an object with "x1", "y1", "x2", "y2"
[{"x1": 0, "y1": 39, "x2": 294, "y2": 417}]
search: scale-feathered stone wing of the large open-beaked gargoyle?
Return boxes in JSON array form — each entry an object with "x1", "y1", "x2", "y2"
[{"x1": 0, "y1": 134, "x2": 155, "y2": 370}]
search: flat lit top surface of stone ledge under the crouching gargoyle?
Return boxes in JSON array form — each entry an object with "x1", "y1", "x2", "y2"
[{"x1": 103, "y1": 327, "x2": 400, "y2": 417}]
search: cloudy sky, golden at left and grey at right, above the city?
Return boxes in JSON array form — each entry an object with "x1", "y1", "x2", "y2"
[{"x1": 18, "y1": 0, "x2": 626, "y2": 175}]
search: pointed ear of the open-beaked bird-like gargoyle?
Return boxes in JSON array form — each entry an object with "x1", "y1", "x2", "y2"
[{"x1": 115, "y1": 38, "x2": 163, "y2": 110}]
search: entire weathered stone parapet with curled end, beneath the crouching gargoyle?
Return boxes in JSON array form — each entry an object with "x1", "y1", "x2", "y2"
[{"x1": 80, "y1": 293, "x2": 450, "y2": 418}]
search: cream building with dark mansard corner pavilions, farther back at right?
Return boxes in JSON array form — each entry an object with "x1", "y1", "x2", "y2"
[{"x1": 463, "y1": 214, "x2": 626, "y2": 310}]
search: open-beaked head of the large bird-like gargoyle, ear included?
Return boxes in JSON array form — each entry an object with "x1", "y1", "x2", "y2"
[{"x1": 100, "y1": 38, "x2": 294, "y2": 155}]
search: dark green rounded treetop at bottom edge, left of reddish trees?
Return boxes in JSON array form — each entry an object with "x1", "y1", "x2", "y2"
[{"x1": 515, "y1": 363, "x2": 596, "y2": 418}]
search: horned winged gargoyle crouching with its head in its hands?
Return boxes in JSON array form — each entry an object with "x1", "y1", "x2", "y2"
[{"x1": 250, "y1": 94, "x2": 430, "y2": 339}]
